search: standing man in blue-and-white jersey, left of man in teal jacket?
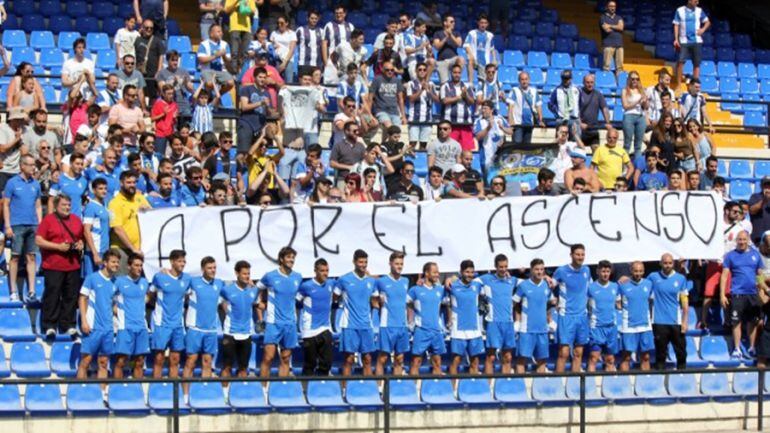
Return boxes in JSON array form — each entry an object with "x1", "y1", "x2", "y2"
[{"x1": 507, "y1": 71, "x2": 545, "y2": 145}]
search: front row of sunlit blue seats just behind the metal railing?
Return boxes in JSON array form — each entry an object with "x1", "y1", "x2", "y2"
[{"x1": 0, "y1": 372, "x2": 767, "y2": 416}]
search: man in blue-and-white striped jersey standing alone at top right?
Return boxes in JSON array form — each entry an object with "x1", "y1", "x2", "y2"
[{"x1": 674, "y1": 0, "x2": 711, "y2": 83}]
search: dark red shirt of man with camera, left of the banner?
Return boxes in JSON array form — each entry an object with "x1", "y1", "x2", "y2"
[{"x1": 36, "y1": 213, "x2": 83, "y2": 272}]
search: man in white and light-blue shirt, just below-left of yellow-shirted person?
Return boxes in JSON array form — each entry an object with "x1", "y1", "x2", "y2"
[{"x1": 198, "y1": 23, "x2": 234, "y2": 95}]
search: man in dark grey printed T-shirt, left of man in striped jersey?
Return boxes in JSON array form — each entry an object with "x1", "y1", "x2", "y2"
[{"x1": 368, "y1": 61, "x2": 406, "y2": 130}]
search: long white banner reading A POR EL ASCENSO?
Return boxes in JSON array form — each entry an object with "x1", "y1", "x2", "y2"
[{"x1": 139, "y1": 192, "x2": 724, "y2": 279}]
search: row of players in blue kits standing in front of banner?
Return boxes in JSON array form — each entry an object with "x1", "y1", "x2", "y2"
[{"x1": 78, "y1": 244, "x2": 688, "y2": 395}]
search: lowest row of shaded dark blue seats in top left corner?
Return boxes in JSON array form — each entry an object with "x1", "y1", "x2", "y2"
[{"x1": 0, "y1": 14, "x2": 181, "y2": 35}]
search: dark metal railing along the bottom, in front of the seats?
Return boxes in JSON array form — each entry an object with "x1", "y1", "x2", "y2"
[{"x1": 6, "y1": 367, "x2": 770, "y2": 433}]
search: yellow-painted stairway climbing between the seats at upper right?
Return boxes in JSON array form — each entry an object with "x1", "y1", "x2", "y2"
[{"x1": 543, "y1": 0, "x2": 767, "y2": 156}]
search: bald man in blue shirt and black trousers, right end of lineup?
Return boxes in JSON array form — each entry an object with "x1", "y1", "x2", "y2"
[{"x1": 647, "y1": 253, "x2": 688, "y2": 370}]
